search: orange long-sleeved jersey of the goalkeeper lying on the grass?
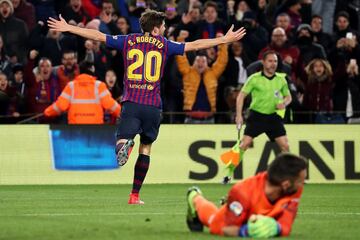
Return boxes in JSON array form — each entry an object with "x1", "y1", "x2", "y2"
[{"x1": 210, "y1": 172, "x2": 303, "y2": 236}]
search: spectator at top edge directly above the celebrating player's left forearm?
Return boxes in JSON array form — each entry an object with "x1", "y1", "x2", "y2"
[{"x1": 62, "y1": 0, "x2": 91, "y2": 27}]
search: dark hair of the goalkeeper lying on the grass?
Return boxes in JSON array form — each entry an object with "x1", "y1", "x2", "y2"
[{"x1": 268, "y1": 153, "x2": 308, "y2": 185}]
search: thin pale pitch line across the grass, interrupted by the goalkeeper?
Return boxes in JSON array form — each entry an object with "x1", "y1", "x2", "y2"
[{"x1": 0, "y1": 212, "x2": 360, "y2": 217}]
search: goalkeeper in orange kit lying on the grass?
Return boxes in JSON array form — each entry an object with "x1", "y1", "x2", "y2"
[{"x1": 186, "y1": 153, "x2": 307, "y2": 238}]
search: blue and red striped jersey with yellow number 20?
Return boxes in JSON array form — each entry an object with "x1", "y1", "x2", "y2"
[{"x1": 106, "y1": 33, "x2": 185, "y2": 108}]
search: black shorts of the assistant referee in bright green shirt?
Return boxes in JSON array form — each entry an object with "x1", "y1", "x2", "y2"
[{"x1": 244, "y1": 110, "x2": 286, "y2": 141}]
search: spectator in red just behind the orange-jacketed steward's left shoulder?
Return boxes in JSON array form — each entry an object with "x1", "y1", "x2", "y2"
[{"x1": 54, "y1": 50, "x2": 80, "y2": 91}]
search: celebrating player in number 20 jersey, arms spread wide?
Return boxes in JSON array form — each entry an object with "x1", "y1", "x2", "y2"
[{"x1": 48, "y1": 10, "x2": 245, "y2": 204}]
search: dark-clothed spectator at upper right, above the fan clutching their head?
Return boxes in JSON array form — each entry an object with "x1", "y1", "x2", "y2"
[{"x1": 311, "y1": 15, "x2": 333, "y2": 54}]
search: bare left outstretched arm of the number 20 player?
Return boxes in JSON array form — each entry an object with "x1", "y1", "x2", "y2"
[{"x1": 47, "y1": 15, "x2": 106, "y2": 42}]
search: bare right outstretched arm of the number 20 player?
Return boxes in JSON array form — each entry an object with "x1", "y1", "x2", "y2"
[{"x1": 185, "y1": 25, "x2": 246, "y2": 52}]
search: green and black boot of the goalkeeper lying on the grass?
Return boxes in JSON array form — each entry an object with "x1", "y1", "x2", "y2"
[{"x1": 186, "y1": 187, "x2": 204, "y2": 232}]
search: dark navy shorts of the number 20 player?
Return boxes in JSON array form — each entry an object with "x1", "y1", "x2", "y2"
[{"x1": 116, "y1": 102, "x2": 161, "y2": 144}]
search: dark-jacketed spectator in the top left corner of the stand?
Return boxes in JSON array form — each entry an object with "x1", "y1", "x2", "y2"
[{"x1": 0, "y1": 0, "x2": 28, "y2": 62}]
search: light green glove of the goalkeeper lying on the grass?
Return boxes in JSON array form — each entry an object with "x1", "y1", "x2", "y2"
[{"x1": 248, "y1": 215, "x2": 279, "y2": 238}]
